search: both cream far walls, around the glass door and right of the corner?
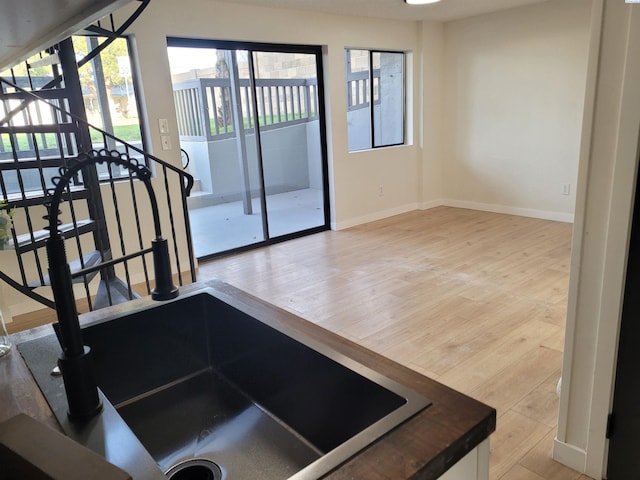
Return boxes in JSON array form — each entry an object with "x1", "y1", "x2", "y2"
[{"x1": 114, "y1": 0, "x2": 591, "y2": 232}]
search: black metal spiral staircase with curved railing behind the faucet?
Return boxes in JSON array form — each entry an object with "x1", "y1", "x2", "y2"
[{"x1": 0, "y1": 6, "x2": 196, "y2": 318}]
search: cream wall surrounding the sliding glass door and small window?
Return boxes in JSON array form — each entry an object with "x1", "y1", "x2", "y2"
[{"x1": 116, "y1": 0, "x2": 430, "y2": 228}]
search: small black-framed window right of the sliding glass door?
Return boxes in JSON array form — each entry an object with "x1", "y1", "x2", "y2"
[{"x1": 345, "y1": 49, "x2": 405, "y2": 152}]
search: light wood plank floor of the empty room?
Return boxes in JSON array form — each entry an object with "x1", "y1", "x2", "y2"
[{"x1": 199, "y1": 207, "x2": 588, "y2": 480}]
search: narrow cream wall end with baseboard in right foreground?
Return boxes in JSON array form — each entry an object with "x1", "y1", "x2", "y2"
[{"x1": 554, "y1": 0, "x2": 640, "y2": 478}]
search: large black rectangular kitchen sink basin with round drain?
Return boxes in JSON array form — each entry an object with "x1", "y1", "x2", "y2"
[{"x1": 21, "y1": 289, "x2": 430, "y2": 480}]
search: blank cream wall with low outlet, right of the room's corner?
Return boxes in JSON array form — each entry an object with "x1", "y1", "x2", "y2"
[{"x1": 442, "y1": 0, "x2": 591, "y2": 221}]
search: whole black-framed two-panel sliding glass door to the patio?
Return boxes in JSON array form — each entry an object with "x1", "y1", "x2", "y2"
[{"x1": 168, "y1": 38, "x2": 329, "y2": 258}]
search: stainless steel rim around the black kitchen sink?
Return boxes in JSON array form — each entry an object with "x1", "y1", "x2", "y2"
[{"x1": 19, "y1": 287, "x2": 431, "y2": 480}]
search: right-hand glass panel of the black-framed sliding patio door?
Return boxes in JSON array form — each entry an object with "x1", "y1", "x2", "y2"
[{"x1": 253, "y1": 51, "x2": 325, "y2": 237}]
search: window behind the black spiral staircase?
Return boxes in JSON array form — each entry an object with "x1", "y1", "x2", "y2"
[{"x1": 0, "y1": 36, "x2": 145, "y2": 195}]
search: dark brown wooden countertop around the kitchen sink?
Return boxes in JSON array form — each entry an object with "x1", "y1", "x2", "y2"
[{"x1": 0, "y1": 280, "x2": 496, "y2": 480}]
